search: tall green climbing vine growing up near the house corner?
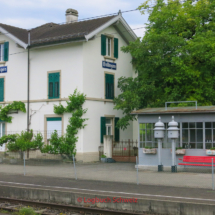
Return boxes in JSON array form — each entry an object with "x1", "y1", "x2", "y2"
[{"x1": 41, "y1": 90, "x2": 87, "y2": 158}]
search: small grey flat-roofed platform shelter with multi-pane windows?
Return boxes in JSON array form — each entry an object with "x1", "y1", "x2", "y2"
[{"x1": 132, "y1": 106, "x2": 215, "y2": 166}]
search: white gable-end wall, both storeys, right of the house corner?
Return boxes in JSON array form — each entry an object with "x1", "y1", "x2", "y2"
[{"x1": 83, "y1": 26, "x2": 133, "y2": 152}]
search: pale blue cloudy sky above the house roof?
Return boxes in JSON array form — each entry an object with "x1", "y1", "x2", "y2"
[{"x1": 0, "y1": 0, "x2": 147, "y2": 37}]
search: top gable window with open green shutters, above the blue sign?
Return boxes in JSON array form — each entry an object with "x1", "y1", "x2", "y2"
[{"x1": 101, "y1": 34, "x2": 119, "y2": 58}]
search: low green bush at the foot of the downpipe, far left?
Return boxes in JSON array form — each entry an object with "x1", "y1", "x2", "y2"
[{"x1": 0, "y1": 130, "x2": 44, "y2": 152}]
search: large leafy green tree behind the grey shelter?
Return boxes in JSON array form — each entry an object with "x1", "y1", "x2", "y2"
[{"x1": 115, "y1": 0, "x2": 215, "y2": 129}]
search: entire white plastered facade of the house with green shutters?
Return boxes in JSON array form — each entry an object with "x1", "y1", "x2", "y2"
[{"x1": 0, "y1": 15, "x2": 137, "y2": 161}]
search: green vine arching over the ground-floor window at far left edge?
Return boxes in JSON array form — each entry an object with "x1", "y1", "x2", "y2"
[{"x1": 0, "y1": 101, "x2": 26, "y2": 123}]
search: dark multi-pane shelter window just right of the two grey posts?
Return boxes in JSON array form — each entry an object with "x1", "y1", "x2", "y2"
[{"x1": 182, "y1": 122, "x2": 203, "y2": 149}]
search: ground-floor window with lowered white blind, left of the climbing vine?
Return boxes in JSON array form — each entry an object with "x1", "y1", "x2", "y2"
[{"x1": 46, "y1": 117, "x2": 62, "y2": 142}]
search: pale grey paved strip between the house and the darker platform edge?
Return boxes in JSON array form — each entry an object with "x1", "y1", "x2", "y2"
[{"x1": 0, "y1": 163, "x2": 212, "y2": 189}]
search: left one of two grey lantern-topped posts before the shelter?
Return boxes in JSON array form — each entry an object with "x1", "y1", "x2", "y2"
[{"x1": 154, "y1": 117, "x2": 165, "y2": 172}]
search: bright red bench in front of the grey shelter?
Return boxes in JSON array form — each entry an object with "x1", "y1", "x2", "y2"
[{"x1": 178, "y1": 156, "x2": 215, "y2": 166}]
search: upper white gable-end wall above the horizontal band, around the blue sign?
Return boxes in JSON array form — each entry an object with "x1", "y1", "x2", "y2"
[{"x1": 83, "y1": 26, "x2": 133, "y2": 99}]
